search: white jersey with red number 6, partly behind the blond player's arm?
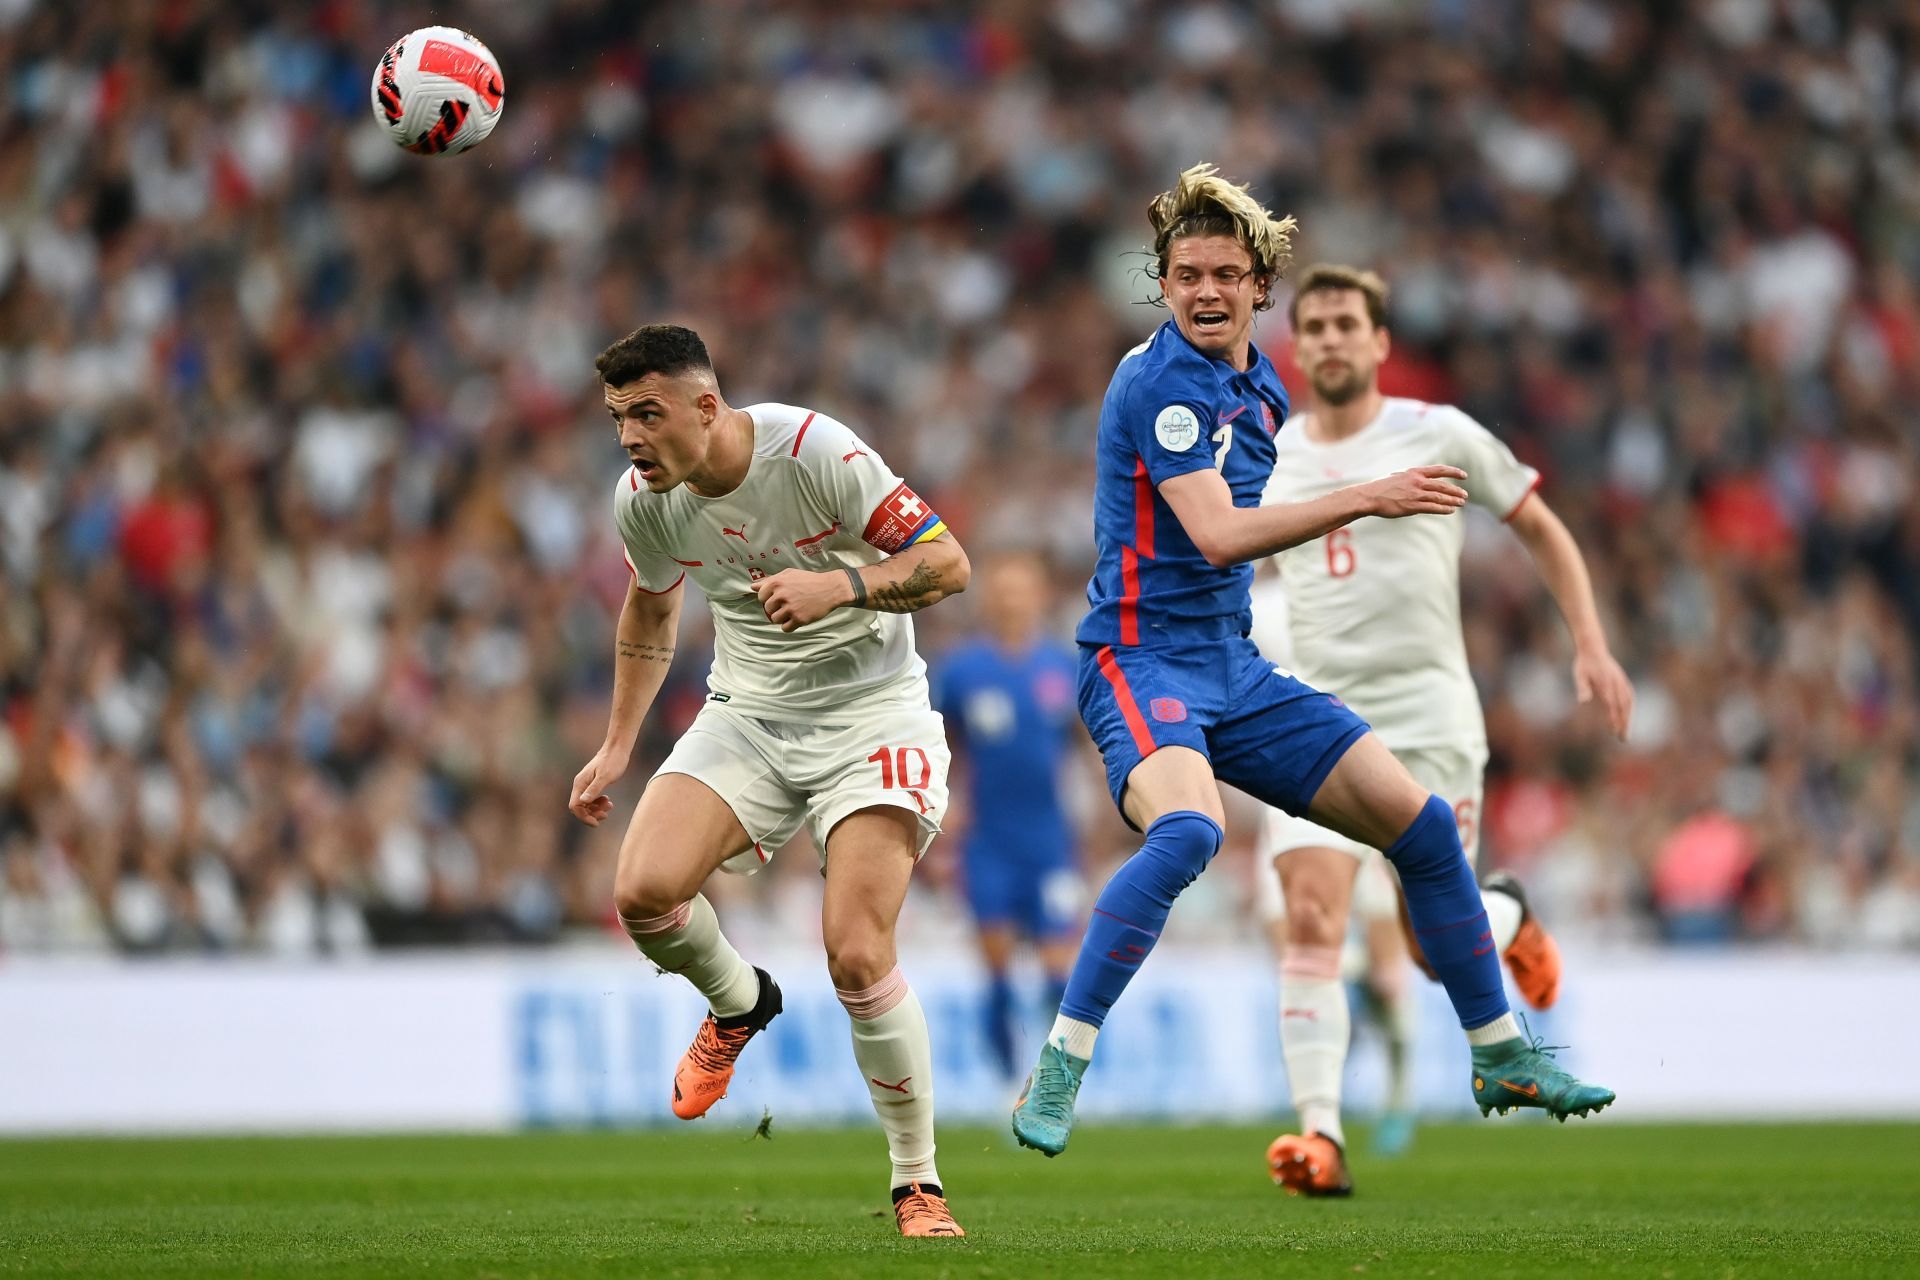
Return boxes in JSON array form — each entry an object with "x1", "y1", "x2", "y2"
[{"x1": 1254, "y1": 399, "x2": 1540, "y2": 750}]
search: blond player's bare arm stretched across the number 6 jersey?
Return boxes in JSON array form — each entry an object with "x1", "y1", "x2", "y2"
[{"x1": 1160, "y1": 454, "x2": 1467, "y2": 568}]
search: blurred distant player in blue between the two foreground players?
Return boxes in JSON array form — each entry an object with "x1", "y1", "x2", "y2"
[{"x1": 935, "y1": 551, "x2": 1081, "y2": 1075}]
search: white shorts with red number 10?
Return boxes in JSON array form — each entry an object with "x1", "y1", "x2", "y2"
[{"x1": 655, "y1": 702, "x2": 948, "y2": 875}]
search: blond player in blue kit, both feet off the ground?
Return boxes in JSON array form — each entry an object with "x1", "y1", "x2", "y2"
[{"x1": 1014, "y1": 165, "x2": 1613, "y2": 1155}]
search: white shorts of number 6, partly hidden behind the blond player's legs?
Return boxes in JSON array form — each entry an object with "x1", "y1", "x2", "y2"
[{"x1": 1254, "y1": 747, "x2": 1486, "y2": 921}]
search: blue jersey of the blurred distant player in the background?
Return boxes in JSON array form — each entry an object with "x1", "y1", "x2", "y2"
[{"x1": 935, "y1": 639, "x2": 1075, "y2": 862}]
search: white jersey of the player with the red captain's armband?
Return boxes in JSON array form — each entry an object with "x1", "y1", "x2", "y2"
[{"x1": 614, "y1": 405, "x2": 947, "y2": 723}]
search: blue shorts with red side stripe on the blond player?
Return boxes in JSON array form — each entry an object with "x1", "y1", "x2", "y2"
[{"x1": 1079, "y1": 635, "x2": 1367, "y2": 818}]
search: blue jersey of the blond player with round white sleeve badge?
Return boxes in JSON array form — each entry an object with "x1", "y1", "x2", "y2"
[{"x1": 1077, "y1": 320, "x2": 1286, "y2": 647}]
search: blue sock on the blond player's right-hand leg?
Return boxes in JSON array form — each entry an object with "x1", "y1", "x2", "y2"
[{"x1": 1386, "y1": 796, "x2": 1507, "y2": 1029}]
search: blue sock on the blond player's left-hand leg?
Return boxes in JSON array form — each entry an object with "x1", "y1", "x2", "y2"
[{"x1": 1060, "y1": 810, "x2": 1221, "y2": 1027}]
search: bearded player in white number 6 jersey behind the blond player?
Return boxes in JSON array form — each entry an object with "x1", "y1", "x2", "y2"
[{"x1": 1256, "y1": 267, "x2": 1634, "y2": 1196}]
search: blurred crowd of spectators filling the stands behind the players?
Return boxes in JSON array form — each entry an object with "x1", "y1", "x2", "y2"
[{"x1": 0, "y1": 0, "x2": 1920, "y2": 954}]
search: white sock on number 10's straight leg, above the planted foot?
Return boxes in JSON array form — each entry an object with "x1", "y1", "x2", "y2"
[{"x1": 833, "y1": 965, "x2": 941, "y2": 1188}]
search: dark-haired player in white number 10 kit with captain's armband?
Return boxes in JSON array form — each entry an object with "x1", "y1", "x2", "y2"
[{"x1": 568, "y1": 324, "x2": 970, "y2": 1236}]
